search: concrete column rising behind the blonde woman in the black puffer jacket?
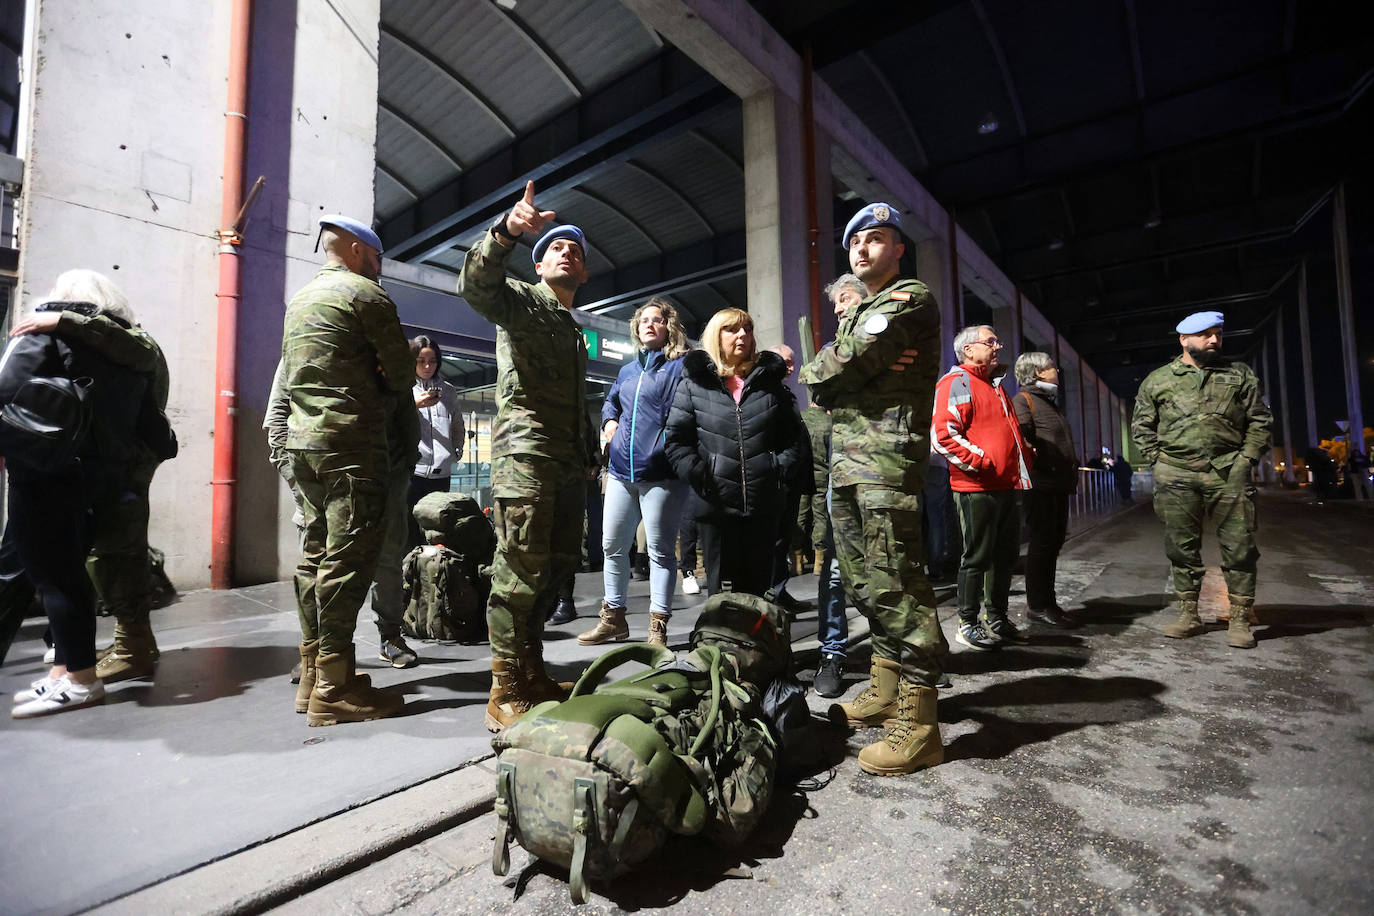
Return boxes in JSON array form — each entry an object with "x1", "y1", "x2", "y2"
[{"x1": 743, "y1": 89, "x2": 811, "y2": 387}]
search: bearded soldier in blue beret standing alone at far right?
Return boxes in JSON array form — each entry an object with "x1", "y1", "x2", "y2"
[{"x1": 1131, "y1": 312, "x2": 1274, "y2": 648}]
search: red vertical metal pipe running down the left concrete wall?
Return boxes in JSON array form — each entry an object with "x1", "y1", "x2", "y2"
[{"x1": 210, "y1": 0, "x2": 253, "y2": 589}]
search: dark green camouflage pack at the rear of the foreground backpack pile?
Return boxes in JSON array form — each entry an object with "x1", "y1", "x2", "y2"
[{"x1": 691, "y1": 591, "x2": 791, "y2": 691}]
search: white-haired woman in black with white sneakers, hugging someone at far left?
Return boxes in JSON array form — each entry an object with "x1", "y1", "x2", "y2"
[{"x1": 0, "y1": 271, "x2": 174, "y2": 718}]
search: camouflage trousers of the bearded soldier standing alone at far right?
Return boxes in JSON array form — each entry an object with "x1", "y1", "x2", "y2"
[{"x1": 1154, "y1": 461, "x2": 1260, "y2": 600}]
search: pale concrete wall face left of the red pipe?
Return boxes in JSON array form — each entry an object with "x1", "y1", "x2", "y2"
[{"x1": 19, "y1": 0, "x2": 229, "y2": 588}]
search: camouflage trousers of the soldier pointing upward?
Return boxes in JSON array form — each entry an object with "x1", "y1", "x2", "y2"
[{"x1": 486, "y1": 455, "x2": 587, "y2": 658}]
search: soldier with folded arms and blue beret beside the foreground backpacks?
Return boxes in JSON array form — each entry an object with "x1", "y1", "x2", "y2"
[{"x1": 801, "y1": 203, "x2": 944, "y2": 776}]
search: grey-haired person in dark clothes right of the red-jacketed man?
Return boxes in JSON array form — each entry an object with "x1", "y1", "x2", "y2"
[{"x1": 1011, "y1": 352, "x2": 1079, "y2": 628}]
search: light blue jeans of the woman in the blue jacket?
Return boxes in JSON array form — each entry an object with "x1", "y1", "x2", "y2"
[{"x1": 602, "y1": 474, "x2": 687, "y2": 615}]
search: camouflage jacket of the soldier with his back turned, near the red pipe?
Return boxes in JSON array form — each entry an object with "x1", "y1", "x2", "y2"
[{"x1": 282, "y1": 264, "x2": 406, "y2": 452}]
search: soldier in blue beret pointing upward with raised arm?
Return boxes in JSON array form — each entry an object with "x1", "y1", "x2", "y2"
[{"x1": 459, "y1": 181, "x2": 596, "y2": 732}]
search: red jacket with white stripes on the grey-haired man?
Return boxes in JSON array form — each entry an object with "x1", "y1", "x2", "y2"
[{"x1": 930, "y1": 364, "x2": 1032, "y2": 493}]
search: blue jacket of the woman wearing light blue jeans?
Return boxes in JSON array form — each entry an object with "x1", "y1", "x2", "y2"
[{"x1": 602, "y1": 350, "x2": 683, "y2": 482}]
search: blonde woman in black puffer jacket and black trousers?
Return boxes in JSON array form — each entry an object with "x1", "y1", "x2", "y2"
[{"x1": 665, "y1": 309, "x2": 809, "y2": 595}]
